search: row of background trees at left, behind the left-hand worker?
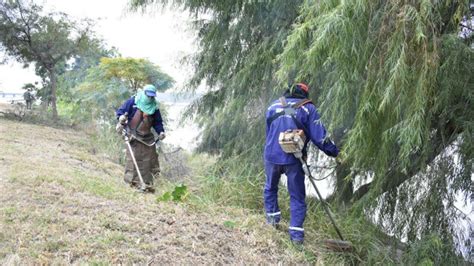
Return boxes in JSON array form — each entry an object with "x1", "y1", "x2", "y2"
[{"x1": 0, "y1": 0, "x2": 174, "y2": 120}]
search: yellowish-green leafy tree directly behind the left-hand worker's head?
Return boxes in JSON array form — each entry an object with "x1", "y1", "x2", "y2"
[{"x1": 56, "y1": 55, "x2": 174, "y2": 123}]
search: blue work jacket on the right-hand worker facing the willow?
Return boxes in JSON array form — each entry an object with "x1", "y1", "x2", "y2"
[{"x1": 264, "y1": 98, "x2": 339, "y2": 165}]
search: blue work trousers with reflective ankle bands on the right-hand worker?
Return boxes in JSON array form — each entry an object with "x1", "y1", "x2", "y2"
[{"x1": 263, "y1": 162, "x2": 306, "y2": 241}]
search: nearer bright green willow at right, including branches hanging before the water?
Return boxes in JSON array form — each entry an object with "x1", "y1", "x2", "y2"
[{"x1": 279, "y1": 0, "x2": 474, "y2": 263}]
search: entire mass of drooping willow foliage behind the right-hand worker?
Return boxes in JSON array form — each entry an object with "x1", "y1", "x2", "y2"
[{"x1": 130, "y1": 0, "x2": 474, "y2": 263}]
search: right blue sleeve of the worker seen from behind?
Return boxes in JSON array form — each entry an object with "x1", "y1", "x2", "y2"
[{"x1": 305, "y1": 104, "x2": 339, "y2": 157}]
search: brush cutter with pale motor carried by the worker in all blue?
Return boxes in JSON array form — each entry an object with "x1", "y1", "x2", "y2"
[{"x1": 278, "y1": 129, "x2": 352, "y2": 252}]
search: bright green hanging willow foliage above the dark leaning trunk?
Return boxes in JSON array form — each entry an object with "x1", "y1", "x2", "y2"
[{"x1": 280, "y1": 1, "x2": 473, "y2": 178}]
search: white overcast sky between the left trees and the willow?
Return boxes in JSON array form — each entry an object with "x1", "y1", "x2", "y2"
[{"x1": 0, "y1": 0, "x2": 194, "y2": 91}]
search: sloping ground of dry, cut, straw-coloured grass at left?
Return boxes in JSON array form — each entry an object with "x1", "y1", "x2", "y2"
[{"x1": 0, "y1": 117, "x2": 312, "y2": 265}]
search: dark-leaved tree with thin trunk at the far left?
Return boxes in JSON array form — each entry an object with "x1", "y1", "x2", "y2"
[{"x1": 0, "y1": 0, "x2": 94, "y2": 119}]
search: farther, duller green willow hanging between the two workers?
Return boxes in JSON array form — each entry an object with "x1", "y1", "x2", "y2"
[{"x1": 130, "y1": 0, "x2": 301, "y2": 169}]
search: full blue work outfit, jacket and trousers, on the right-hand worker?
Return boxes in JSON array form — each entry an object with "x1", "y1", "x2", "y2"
[{"x1": 263, "y1": 98, "x2": 339, "y2": 242}]
